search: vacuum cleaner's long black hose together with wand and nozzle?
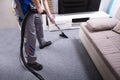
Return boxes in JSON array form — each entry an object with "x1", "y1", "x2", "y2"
[{"x1": 20, "y1": 9, "x2": 68, "y2": 80}]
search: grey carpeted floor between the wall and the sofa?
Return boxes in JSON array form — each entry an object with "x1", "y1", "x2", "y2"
[{"x1": 0, "y1": 28, "x2": 102, "y2": 80}]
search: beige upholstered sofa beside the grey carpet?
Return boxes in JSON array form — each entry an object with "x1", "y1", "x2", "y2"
[{"x1": 80, "y1": 9, "x2": 120, "y2": 80}]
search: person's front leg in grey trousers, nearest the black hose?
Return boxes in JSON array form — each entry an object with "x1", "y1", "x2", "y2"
[{"x1": 25, "y1": 14, "x2": 42, "y2": 70}]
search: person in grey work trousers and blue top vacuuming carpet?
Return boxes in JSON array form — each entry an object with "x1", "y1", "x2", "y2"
[{"x1": 13, "y1": 0, "x2": 55, "y2": 70}]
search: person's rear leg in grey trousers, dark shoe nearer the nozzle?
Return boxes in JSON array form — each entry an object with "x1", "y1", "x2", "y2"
[{"x1": 35, "y1": 14, "x2": 51, "y2": 49}]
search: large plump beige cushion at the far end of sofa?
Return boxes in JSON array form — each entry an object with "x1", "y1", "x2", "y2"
[{"x1": 87, "y1": 18, "x2": 119, "y2": 31}]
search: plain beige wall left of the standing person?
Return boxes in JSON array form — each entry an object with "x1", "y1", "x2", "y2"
[{"x1": 0, "y1": 0, "x2": 18, "y2": 28}]
